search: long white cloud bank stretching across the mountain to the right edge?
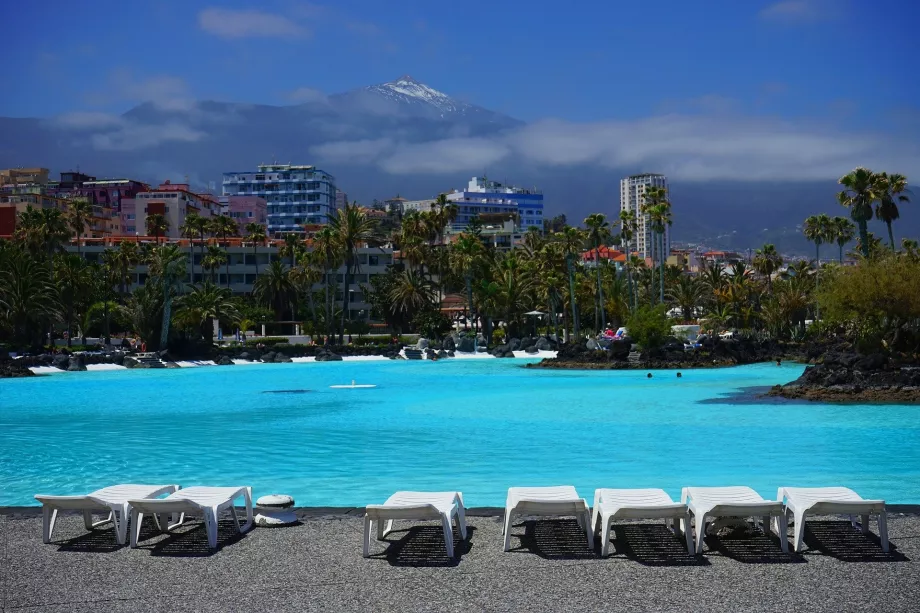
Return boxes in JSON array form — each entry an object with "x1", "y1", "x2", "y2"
[{"x1": 311, "y1": 115, "x2": 920, "y2": 181}]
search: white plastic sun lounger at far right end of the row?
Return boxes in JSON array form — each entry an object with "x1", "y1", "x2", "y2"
[{"x1": 776, "y1": 487, "x2": 888, "y2": 553}]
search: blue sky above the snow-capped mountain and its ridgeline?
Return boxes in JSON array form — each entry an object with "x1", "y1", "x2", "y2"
[{"x1": 0, "y1": 0, "x2": 920, "y2": 129}]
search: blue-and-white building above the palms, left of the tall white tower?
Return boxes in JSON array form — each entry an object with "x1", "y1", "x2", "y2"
[{"x1": 447, "y1": 177, "x2": 543, "y2": 232}]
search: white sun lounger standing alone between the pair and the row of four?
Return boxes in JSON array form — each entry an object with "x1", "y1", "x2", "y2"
[{"x1": 364, "y1": 492, "x2": 466, "y2": 558}]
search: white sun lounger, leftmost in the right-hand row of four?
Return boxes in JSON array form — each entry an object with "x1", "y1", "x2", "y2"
[{"x1": 502, "y1": 485, "x2": 594, "y2": 551}]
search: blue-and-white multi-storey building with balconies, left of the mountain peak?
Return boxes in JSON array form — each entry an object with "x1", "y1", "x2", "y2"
[{"x1": 223, "y1": 164, "x2": 345, "y2": 236}]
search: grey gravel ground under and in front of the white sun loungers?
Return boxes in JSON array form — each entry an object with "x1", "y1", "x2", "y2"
[{"x1": 0, "y1": 509, "x2": 920, "y2": 613}]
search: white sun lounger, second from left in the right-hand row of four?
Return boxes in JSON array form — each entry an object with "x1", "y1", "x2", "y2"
[{"x1": 591, "y1": 488, "x2": 693, "y2": 557}]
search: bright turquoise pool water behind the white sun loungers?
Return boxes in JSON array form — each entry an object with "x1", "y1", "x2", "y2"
[{"x1": 0, "y1": 360, "x2": 920, "y2": 506}]
